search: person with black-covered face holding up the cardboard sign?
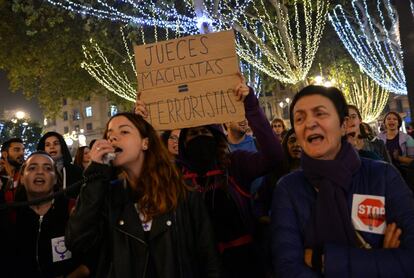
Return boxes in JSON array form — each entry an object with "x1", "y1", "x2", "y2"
[{"x1": 135, "y1": 78, "x2": 282, "y2": 277}]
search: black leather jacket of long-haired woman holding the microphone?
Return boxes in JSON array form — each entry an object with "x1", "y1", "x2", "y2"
[{"x1": 66, "y1": 163, "x2": 220, "y2": 278}]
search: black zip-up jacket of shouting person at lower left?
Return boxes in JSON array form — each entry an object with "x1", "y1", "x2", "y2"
[{"x1": 4, "y1": 197, "x2": 80, "y2": 278}]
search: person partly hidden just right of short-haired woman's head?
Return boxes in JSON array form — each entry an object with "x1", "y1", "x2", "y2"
[{"x1": 346, "y1": 105, "x2": 391, "y2": 163}]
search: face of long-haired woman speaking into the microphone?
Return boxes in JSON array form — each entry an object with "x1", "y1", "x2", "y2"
[{"x1": 106, "y1": 116, "x2": 148, "y2": 169}]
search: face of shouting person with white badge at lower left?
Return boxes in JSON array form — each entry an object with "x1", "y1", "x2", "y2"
[{"x1": 20, "y1": 154, "x2": 57, "y2": 197}]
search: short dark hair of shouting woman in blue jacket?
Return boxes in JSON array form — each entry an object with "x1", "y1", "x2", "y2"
[{"x1": 289, "y1": 85, "x2": 348, "y2": 128}]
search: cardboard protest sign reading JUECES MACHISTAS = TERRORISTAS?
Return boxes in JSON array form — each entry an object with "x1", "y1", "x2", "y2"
[{"x1": 135, "y1": 30, "x2": 244, "y2": 130}]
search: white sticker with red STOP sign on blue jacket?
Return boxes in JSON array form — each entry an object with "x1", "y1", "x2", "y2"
[{"x1": 352, "y1": 194, "x2": 387, "y2": 234}]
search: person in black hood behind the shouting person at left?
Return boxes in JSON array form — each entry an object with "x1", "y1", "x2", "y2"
[{"x1": 37, "y1": 131, "x2": 83, "y2": 198}]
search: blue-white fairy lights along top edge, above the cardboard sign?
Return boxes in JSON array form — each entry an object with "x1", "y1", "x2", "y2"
[{"x1": 47, "y1": 0, "x2": 252, "y2": 35}]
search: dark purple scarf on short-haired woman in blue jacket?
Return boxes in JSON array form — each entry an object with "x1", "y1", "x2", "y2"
[{"x1": 301, "y1": 140, "x2": 361, "y2": 250}]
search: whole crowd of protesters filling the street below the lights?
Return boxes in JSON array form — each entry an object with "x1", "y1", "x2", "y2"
[{"x1": 0, "y1": 81, "x2": 414, "y2": 278}]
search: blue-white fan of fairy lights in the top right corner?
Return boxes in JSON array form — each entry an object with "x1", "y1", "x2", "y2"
[{"x1": 329, "y1": 0, "x2": 407, "y2": 94}]
